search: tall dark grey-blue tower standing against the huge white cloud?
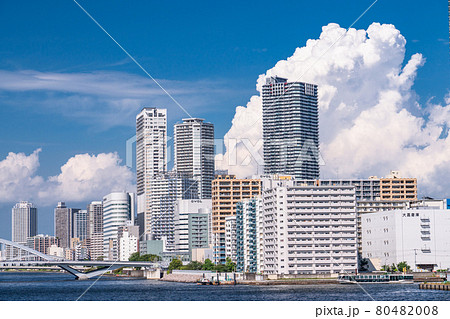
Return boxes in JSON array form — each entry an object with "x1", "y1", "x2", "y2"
[{"x1": 262, "y1": 76, "x2": 319, "y2": 179}]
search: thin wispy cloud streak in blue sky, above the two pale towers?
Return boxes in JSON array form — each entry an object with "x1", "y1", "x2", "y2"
[{"x1": 0, "y1": 70, "x2": 246, "y2": 129}]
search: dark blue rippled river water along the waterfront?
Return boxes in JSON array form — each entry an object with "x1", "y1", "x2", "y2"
[{"x1": 0, "y1": 272, "x2": 450, "y2": 301}]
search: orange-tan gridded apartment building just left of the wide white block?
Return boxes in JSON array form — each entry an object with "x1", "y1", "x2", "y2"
[{"x1": 212, "y1": 175, "x2": 261, "y2": 264}]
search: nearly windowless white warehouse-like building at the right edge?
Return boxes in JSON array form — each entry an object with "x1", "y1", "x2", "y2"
[{"x1": 362, "y1": 208, "x2": 450, "y2": 270}]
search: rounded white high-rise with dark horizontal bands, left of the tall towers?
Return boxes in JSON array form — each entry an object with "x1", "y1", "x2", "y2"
[{"x1": 103, "y1": 192, "x2": 135, "y2": 260}]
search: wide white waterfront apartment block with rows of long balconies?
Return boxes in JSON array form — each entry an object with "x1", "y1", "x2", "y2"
[{"x1": 263, "y1": 181, "x2": 358, "y2": 274}]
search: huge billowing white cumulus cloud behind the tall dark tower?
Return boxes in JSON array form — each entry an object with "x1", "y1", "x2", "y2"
[{"x1": 216, "y1": 23, "x2": 450, "y2": 196}]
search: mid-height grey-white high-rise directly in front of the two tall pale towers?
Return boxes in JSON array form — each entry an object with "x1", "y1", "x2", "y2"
[{"x1": 147, "y1": 172, "x2": 198, "y2": 251}]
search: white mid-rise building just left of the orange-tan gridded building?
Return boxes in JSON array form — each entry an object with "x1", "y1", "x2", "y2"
[{"x1": 174, "y1": 199, "x2": 212, "y2": 254}]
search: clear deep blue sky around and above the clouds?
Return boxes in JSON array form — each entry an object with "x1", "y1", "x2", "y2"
[{"x1": 0, "y1": 0, "x2": 450, "y2": 238}]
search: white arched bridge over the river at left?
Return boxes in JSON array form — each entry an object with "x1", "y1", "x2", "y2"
[{"x1": 0, "y1": 238, "x2": 161, "y2": 279}]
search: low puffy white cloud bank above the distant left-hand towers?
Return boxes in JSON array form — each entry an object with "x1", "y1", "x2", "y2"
[{"x1": 0, "y1": 149, "x2": 135, "y2": 206}]
